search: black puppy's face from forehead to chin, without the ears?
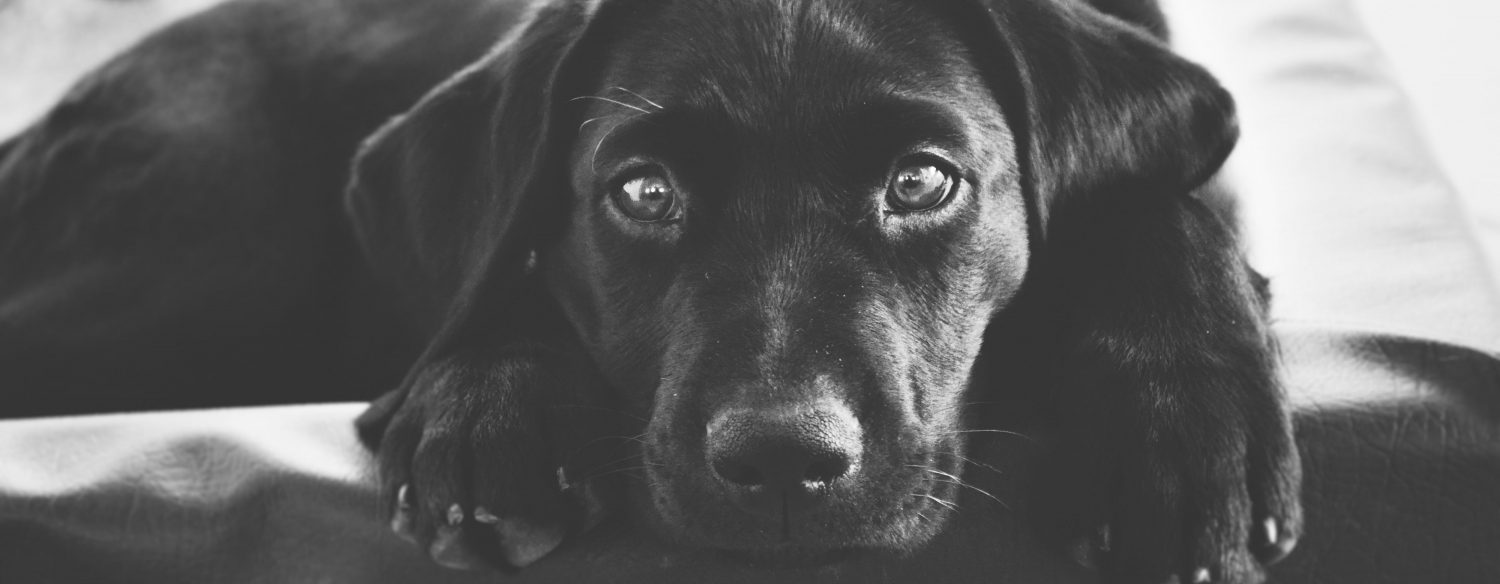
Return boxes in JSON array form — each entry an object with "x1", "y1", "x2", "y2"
[{"x1": 542, "y1": 2, "x2": 1028, "y2": 554}]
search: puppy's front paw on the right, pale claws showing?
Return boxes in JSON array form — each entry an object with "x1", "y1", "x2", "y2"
[{"x1": 1055, "y1": 370, "x2": 1302, "y2": 584}]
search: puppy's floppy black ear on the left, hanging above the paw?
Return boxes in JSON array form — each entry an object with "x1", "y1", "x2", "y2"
[{"x1": 345, "y1": 0, "x2": 597, "y2": 332}]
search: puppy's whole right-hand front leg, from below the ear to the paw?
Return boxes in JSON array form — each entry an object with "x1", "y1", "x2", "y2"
[{"x1": 1053, "y1": 197, "x2": 1301, "y2": 582}]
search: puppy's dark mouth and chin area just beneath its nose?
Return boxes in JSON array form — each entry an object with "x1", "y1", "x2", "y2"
[{"x1": 633, "y1": 444, "x2": 963, "y2": 555}]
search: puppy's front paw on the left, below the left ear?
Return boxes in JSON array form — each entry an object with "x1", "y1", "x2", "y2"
[{"x1": 359, "y1": 350, "x2": 618, "y2": 569}]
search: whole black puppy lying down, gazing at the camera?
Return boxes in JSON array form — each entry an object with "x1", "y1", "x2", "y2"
[{"x1": 0, "y1": 0, "x2": 1301, "y2": 582}]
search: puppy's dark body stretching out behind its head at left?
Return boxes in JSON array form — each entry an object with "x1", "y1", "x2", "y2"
[{"x1": 0, "y1": 0, "x2": 525, "y2": 417}]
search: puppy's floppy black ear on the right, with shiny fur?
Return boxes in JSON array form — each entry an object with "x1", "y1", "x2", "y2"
[{"x1": 966, "y1": 0, "x2": 1239, "y2": 240}]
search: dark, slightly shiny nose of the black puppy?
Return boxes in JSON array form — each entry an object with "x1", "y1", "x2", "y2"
[{"x1": 707, "y1": 402, "x2": 861, "y2": 512}]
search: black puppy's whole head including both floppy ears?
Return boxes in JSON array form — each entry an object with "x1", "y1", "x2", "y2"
[{"x1": 350, "y1": 0, "x2": 1235, "y2": 554}]
